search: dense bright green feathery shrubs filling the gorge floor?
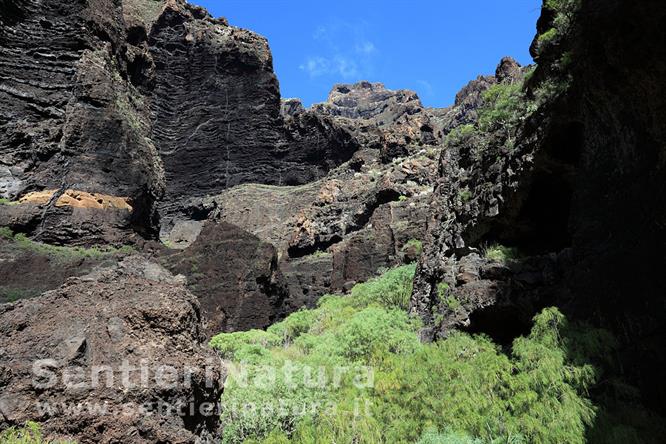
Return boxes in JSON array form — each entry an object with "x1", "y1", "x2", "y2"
[{"x1": 211, "y1": 266, "x2": 652, "y2": 444}]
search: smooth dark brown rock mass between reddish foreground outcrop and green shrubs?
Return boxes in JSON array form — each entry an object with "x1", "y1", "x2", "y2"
[{"x1": 161, "y1": 222, "x2": 287, "y2": 336}]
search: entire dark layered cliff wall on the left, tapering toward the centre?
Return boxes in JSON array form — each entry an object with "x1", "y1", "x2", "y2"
[{"x1": 0, "y1": 0, "x2": 358, "y2": 244}]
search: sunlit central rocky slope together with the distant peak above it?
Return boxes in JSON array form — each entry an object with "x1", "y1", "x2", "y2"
[{"x1": 202, "y1": 82, "x2": 440, "y2": 312}]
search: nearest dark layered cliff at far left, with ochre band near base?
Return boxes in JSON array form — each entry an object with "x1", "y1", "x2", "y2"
[{"x1": 0, "y1": 0, "x2": 164, "y2": 243}]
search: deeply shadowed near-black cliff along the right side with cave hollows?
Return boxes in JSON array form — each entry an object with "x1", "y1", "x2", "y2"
[{"x1": 412, "y1": 0, "x2": 666, "y2": 410}]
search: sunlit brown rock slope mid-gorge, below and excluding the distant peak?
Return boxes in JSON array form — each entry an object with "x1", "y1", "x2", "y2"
[{"x1": 204, "y1": 142, "x2": 437, "y2": 311}]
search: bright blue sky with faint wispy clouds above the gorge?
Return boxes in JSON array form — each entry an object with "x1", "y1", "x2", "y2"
[{"x1": 190, "y1": 0, "x2": 541, "y2": 107}]
